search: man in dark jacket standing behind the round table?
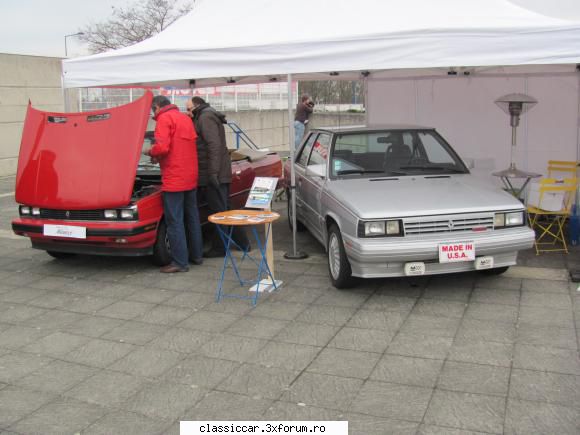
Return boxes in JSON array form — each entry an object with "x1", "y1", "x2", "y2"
[{"x1": 187, "y1": 97, "x2": 250, "y2": 257}]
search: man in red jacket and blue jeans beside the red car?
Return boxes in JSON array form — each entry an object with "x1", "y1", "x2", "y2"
[{"x1": 143, "y1": 95, "x2": 203, "y2": 273}]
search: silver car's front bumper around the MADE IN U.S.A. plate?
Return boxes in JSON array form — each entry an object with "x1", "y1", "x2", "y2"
[{"x1": 342, "y1": 227, "x2": 535, "y2": 278}]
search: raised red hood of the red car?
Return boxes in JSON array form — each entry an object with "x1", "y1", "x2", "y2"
[{"x1": 16, "y1": 92, "x2": 153, "y2": 210}]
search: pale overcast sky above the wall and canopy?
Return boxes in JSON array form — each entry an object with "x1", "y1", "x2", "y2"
[{"x1": 0, "y1": 0, "x2": 580, "y2": 57}]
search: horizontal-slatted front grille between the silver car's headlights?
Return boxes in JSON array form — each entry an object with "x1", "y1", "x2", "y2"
[{"x1": 403, "y1": 213, "x2": 493, "y2": 235}]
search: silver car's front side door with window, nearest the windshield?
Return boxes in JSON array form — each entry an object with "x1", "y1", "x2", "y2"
[{"x1": 302, "y1": 133, "x2": 330, "y2": 240}]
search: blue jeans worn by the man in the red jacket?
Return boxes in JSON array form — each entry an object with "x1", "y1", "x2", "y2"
[{"x1": 163, "y1": 189, "x2": 203, "y2": 268}]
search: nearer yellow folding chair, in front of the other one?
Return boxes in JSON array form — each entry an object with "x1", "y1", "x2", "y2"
[{"x1": 527, "y1": 178, "x2": 577, "y2": 255}]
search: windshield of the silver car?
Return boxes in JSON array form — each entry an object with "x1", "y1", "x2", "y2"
[{"x1": 330, "y1": 130, "x2": 468, "y2": 177}]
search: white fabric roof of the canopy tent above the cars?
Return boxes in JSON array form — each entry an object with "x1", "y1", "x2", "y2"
[{"x1": 63, "y1": 0, "x2": 580, "y2": 88}]
